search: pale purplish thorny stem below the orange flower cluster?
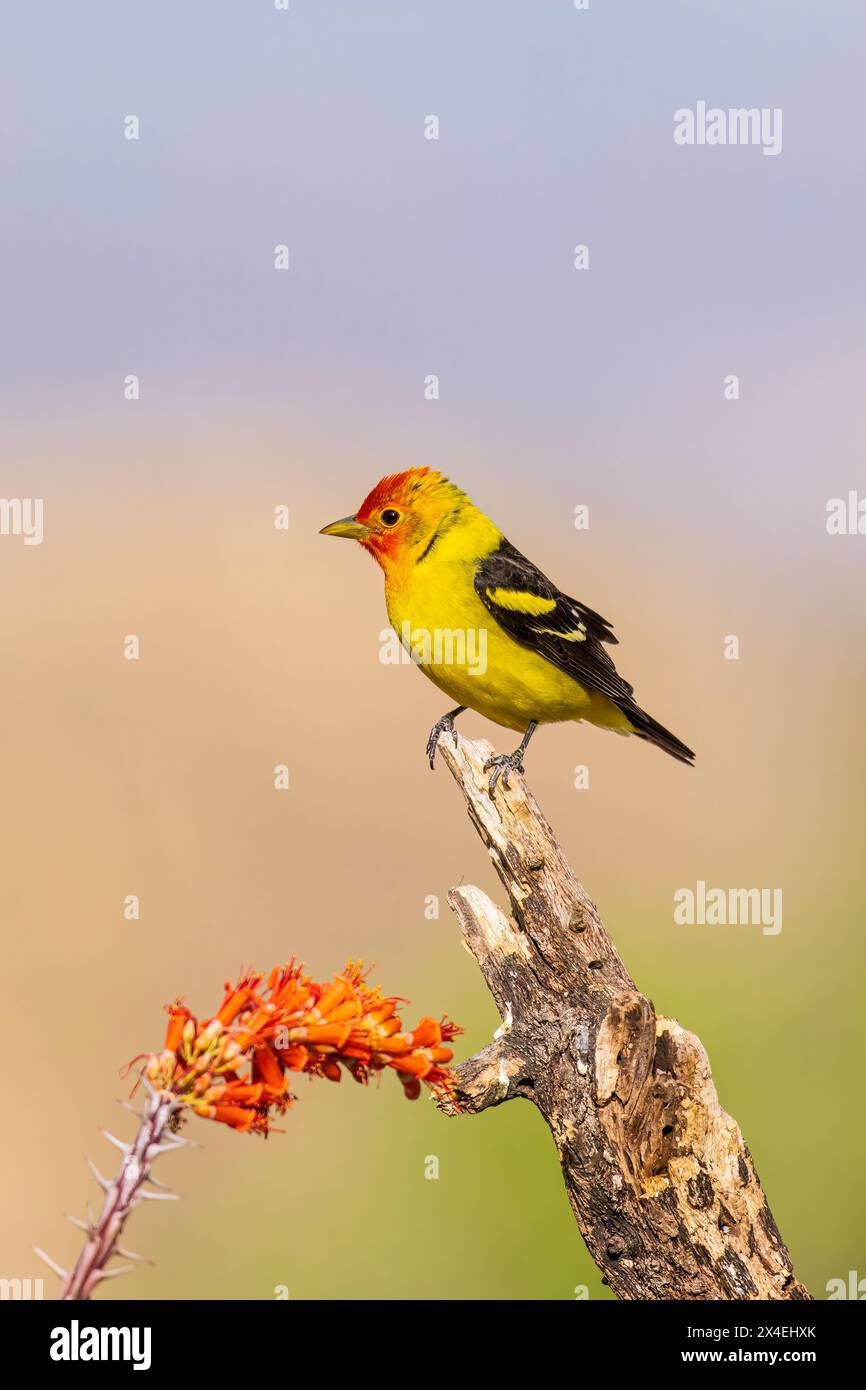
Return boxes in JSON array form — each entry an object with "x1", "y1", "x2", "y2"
[{"x1": 60, "y1": 1090, "x2": 185, "y2": 1301}]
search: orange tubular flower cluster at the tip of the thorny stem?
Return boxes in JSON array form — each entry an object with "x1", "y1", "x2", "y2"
[{"x1": 143, "y1": 960, "x2": 461, "y2": 1134}]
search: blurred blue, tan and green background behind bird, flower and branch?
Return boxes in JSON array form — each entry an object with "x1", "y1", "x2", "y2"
[{"x1": 0, "y1": 0, "x2": 866, "y2": 1300}]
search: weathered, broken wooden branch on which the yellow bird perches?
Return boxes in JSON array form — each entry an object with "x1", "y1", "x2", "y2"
[{"x1": 439, "y1": 733, "x2": 810, "y2": 1300}]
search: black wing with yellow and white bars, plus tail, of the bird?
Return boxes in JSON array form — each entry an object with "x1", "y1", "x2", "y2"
[{"x1": 475, "y1": 539, "x2": 695, "y2": 763}]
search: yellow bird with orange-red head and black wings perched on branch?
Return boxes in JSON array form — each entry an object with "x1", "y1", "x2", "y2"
[{"x1": 320, "y1": 467, "x2": 695, "y2": 795}]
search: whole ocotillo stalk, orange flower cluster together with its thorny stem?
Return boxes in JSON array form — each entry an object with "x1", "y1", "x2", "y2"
[{"x1": 38, "y1": 960, "x2": 460, "y2": 1300}]
